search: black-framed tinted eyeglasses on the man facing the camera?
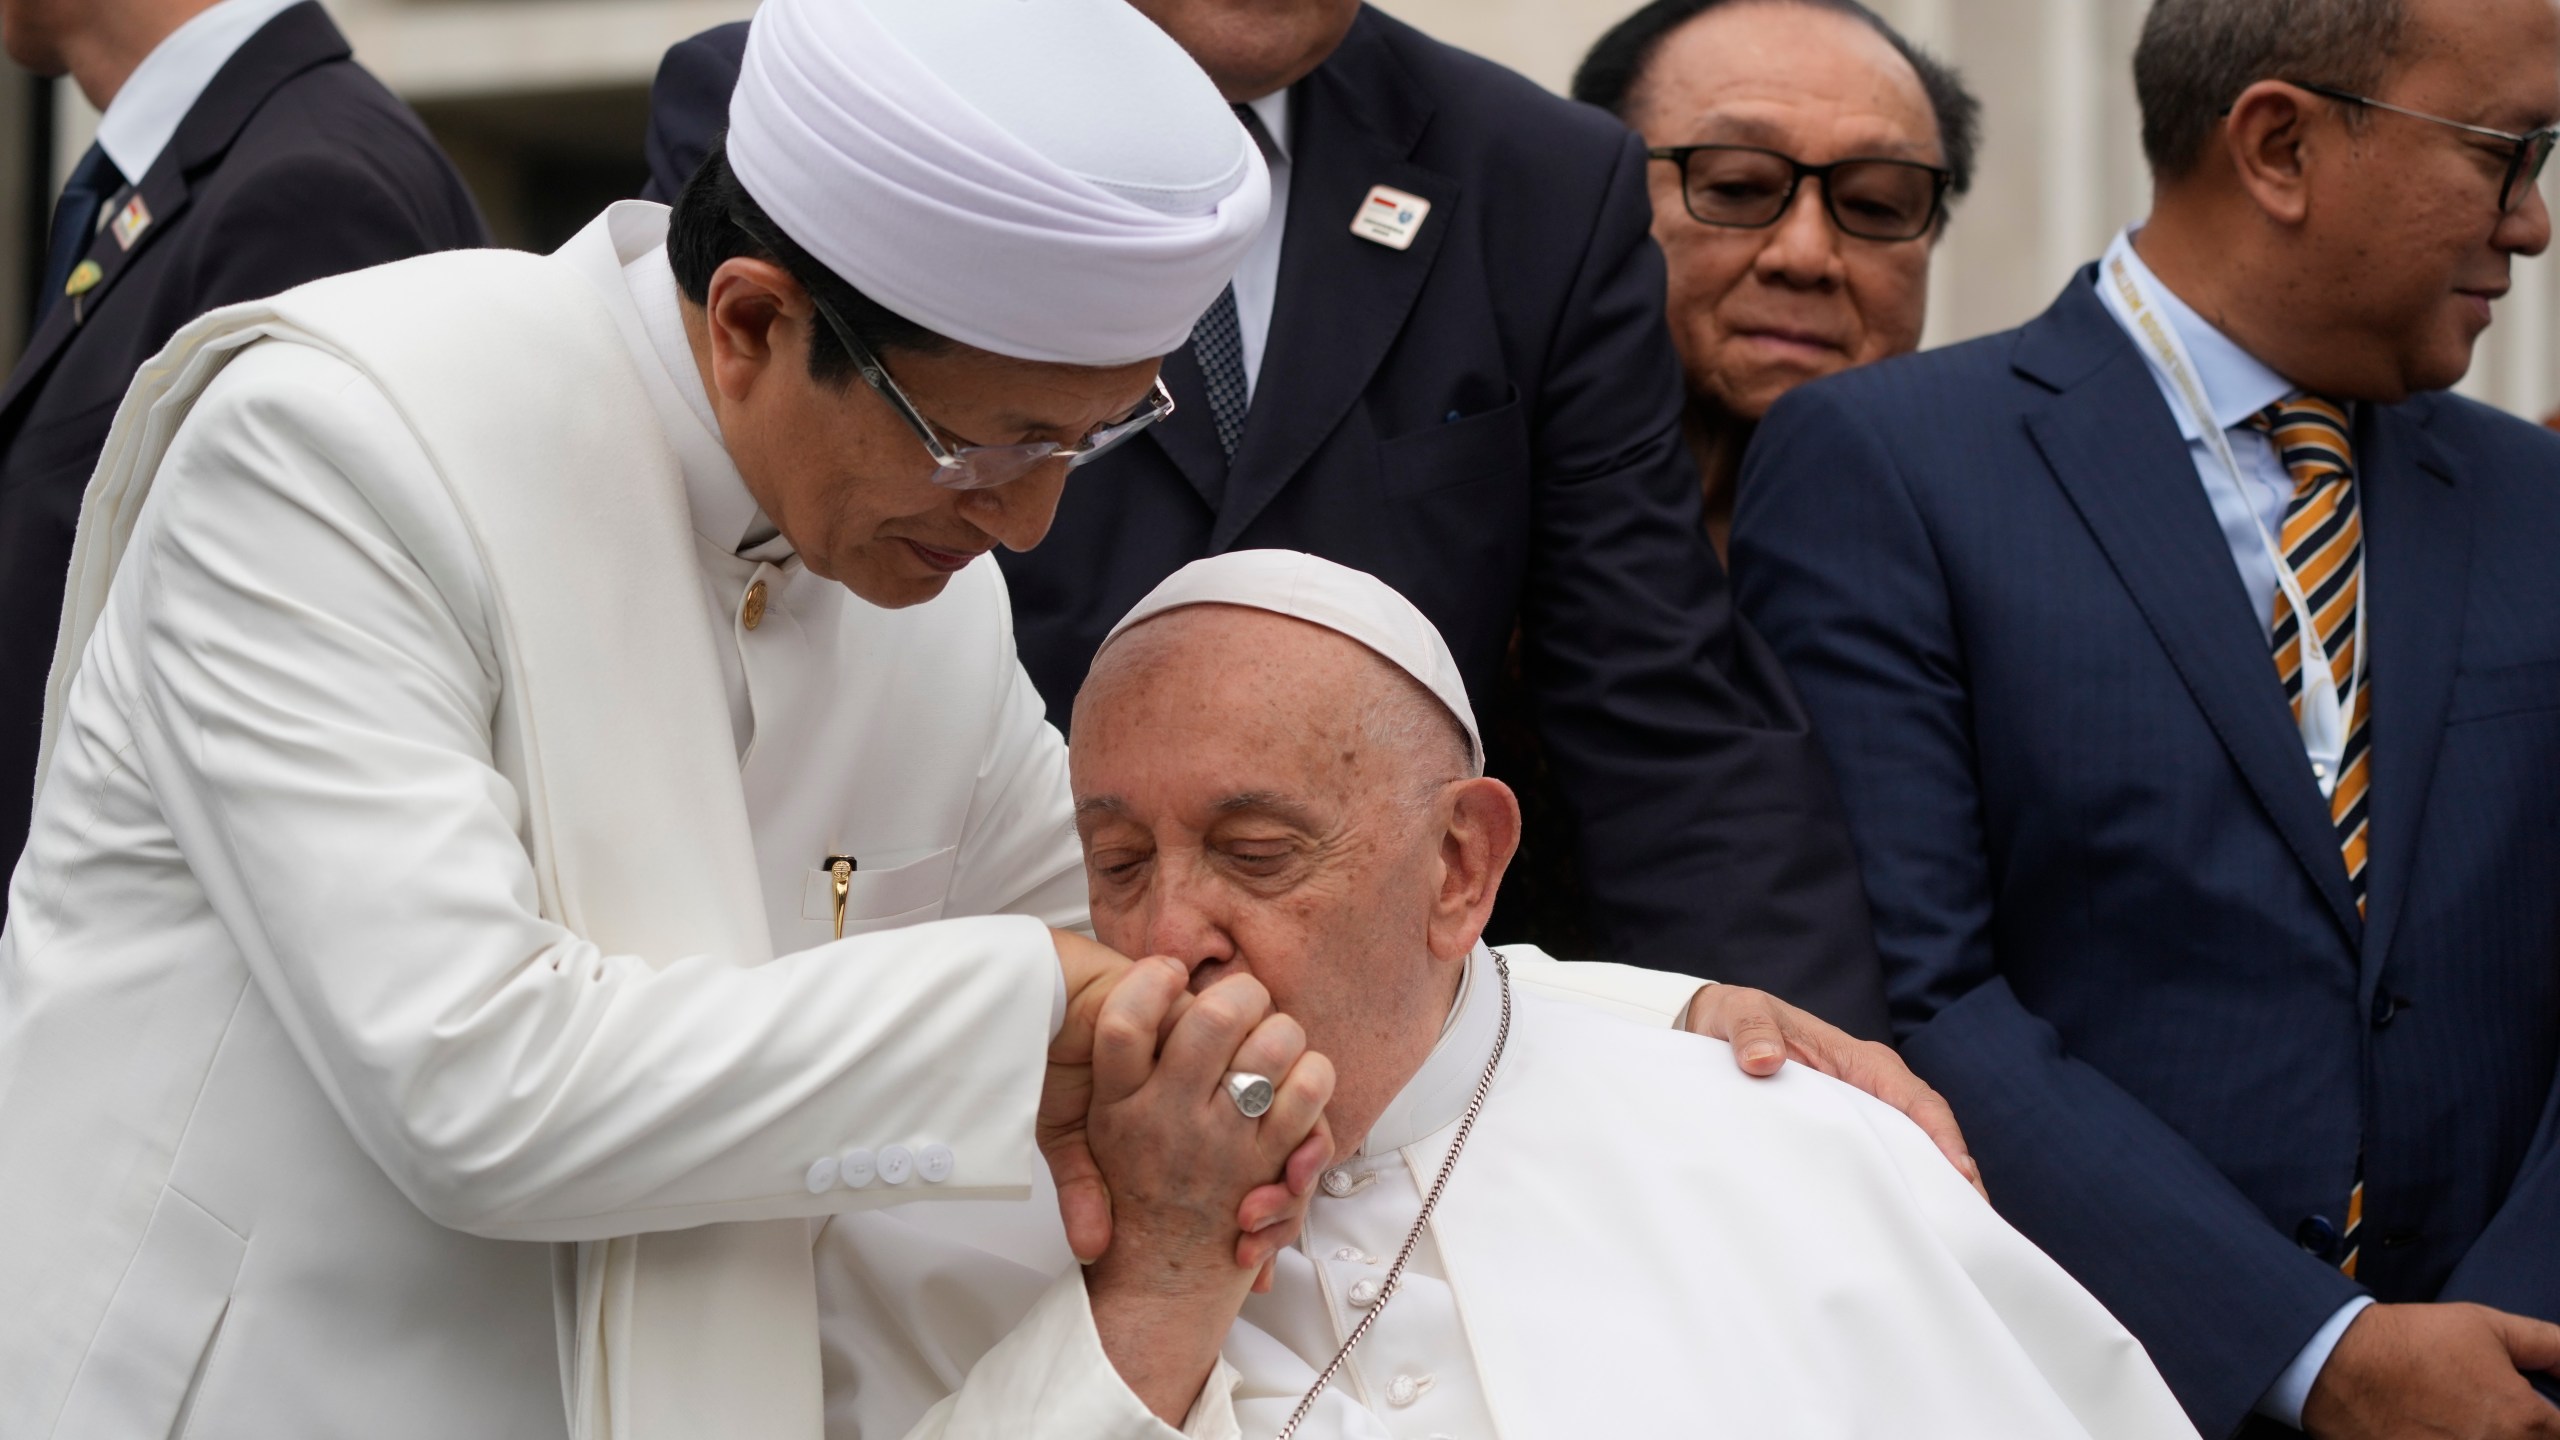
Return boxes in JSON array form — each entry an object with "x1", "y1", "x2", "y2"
[{"x1": 1644, "y1": 146, "x2": 1953, "y2": 241}]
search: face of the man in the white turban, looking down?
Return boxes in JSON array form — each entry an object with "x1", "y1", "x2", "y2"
[{"x1": 686, "y1": 259, "x2": 1155, "y2": 610}]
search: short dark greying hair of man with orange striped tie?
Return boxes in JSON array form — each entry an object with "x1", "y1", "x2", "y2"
[{"x1": 2132, "y1": 0, "x2": 2409, "y2": 179}]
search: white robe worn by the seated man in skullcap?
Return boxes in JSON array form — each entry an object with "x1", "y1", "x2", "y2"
[{"x1": 924, "y1": 953, "x2": 2194, "y2": 1440}]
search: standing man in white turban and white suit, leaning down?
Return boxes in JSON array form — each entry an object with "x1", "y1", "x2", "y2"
[{"x1": 0, "y1": 0, "x2": 1943, "y2": 1440}]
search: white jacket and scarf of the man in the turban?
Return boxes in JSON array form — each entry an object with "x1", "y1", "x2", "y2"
[{"x1": 0, "y1": 208, "x2": 1083, "y2": 1440}]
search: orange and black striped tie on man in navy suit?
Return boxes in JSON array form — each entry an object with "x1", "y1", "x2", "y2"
[{"x1": 2250, "y1": 395, "x2": 2373, "y2": 1279}]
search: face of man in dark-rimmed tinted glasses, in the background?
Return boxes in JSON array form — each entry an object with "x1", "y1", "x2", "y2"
[{"x1": 1628, "y1": 3, "x2": 1943, "y2": 420}]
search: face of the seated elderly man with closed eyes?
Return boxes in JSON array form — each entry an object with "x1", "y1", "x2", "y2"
[{"x1": 1073, "y1": 605, "x2": 1518, "y2": 1145}]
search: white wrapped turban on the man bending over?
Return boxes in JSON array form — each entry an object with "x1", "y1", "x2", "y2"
[{"x1": 727, "y1": 0, "x2": 1270, "y2": 364}]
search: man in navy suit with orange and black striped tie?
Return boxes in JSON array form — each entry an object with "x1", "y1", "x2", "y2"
[{"x1": 1733, "y1": 0, "x2": 2560, "y2": 1437}]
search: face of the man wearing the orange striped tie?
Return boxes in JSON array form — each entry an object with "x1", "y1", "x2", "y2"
[{"x1": 2284, "y1": 0, "x2": 2560, "y2": 402}]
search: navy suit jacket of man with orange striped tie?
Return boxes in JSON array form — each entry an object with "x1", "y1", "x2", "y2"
[{"x1": 1733, "y1": 269, "x2": 2560, "y2": 1435}]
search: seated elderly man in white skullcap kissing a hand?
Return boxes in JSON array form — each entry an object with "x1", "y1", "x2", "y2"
[{"x1": 890, "y1": 551, "x2": 2194, "y2": 1440}]
